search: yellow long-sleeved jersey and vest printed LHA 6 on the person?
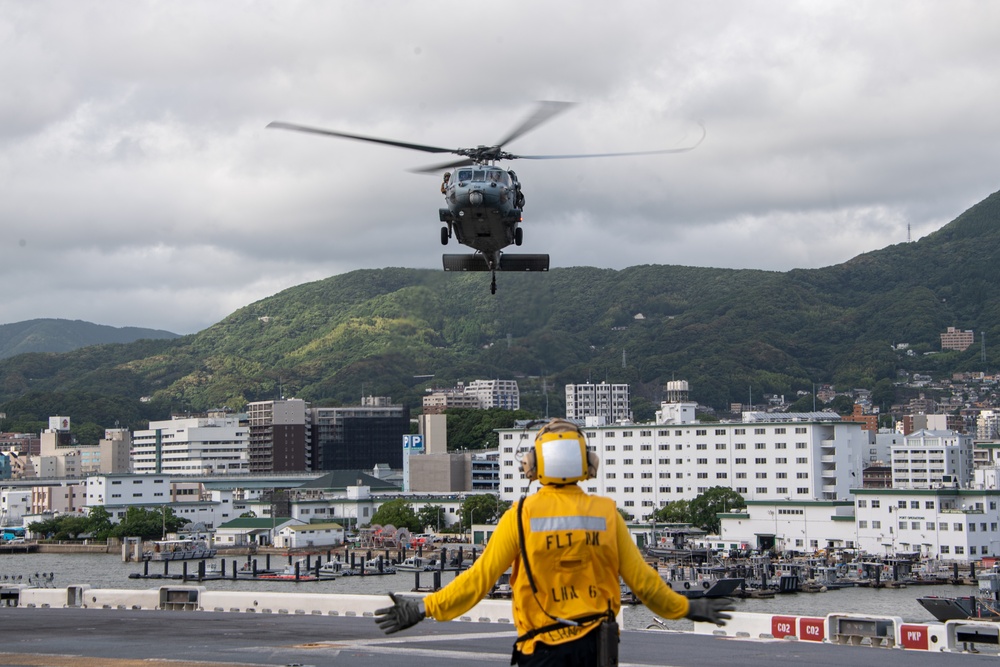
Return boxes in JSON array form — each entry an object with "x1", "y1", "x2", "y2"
[{"x1": 424, "y1": 484, "x2": 688, "y2": 654}]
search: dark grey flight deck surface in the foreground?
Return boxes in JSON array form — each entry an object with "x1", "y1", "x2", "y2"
[{"x1": 0, "y1": 607, "x2": 997, "y2": 667}]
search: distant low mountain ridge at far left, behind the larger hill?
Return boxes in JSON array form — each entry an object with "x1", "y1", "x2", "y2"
[{"x1": 0, "y1": 319, "x2": 178, "y2": 359}]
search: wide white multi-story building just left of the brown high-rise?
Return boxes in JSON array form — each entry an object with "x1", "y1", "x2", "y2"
[{"x1": 131, "y1": 417, "x2": 250, "y2": 475}]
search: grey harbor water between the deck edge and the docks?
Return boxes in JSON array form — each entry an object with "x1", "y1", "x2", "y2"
[{"x1": 0, "y1": 553, "x2": 976, "y2": 630}]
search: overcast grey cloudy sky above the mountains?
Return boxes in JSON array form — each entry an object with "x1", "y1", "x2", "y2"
[{"x1": 0, "y1": 0, "x2": 1000, "y2": 333}]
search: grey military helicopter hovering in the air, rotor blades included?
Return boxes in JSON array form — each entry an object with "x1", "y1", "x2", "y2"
[{"x1": 268, "y1": 101, "x2": 705, "y2": 294}]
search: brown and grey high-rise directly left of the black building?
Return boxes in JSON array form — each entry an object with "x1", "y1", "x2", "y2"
[{"x1": 247, "y1": 398, "x2": 312, "y2": 475}]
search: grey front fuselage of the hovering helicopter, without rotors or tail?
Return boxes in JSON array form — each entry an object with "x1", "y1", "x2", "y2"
[{"x1": 440, "y1": 165, "x2": 524, "y2": 261}]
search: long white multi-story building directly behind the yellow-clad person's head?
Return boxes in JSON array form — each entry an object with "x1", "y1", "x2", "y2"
[{"x1": 500, "y1": 409, "x2": 869, "y2": 520}]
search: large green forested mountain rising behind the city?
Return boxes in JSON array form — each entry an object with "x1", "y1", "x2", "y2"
[{"x1": 0, "y1": 193, "x2": 1000, "y2": 428}]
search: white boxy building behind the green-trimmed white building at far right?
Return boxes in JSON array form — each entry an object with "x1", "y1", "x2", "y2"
[{"x1": 891, "y1": 430, "x2": 973, "y2": 489}]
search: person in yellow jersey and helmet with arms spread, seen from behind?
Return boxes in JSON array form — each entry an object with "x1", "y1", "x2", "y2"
[{"x1": 375, "y1": 419, "x2": 733, "y2": 667}]
